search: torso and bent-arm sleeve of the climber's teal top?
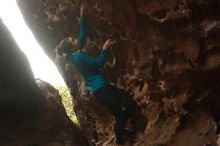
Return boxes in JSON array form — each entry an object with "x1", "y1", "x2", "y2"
[{"x1": 71, "y1": 49, "x2": 108, "y2": 93}]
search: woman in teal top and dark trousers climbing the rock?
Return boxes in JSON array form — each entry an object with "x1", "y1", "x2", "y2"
[{"x1": 56, "y1": 4, "x2": 136, "y2": 146}]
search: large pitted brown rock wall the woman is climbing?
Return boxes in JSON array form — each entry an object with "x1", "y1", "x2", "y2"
[{"x1": 17, "y1": 0, "x2": 220, "y2": 146}]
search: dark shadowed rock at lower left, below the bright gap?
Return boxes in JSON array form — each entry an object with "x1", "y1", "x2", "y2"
[{"x1": 0, "y1": 22, "x2": 88, "y2": 146}]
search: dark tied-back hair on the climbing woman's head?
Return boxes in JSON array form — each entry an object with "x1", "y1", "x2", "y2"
[{"x1": 56, "y1": 38, "x2": 74, "y2": 55}]
